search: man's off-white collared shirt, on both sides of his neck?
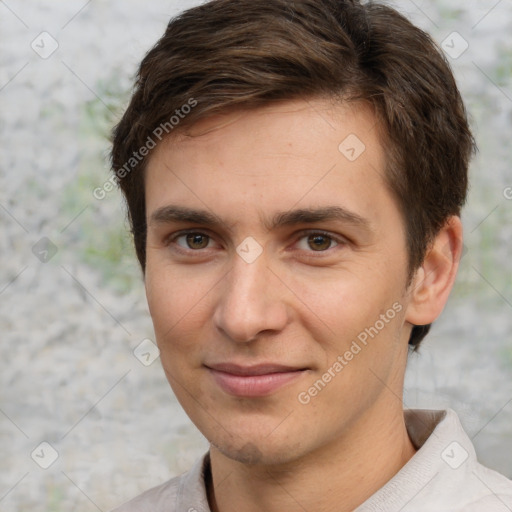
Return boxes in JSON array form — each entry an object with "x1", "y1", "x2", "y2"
[{"x1": 113, "y1": 409, "x2": 512, "y2": 512}]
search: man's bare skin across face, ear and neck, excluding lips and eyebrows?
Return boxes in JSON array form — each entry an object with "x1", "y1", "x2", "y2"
[{"x1": 145, "y1": 98, "x2": 462, "y2": 512}]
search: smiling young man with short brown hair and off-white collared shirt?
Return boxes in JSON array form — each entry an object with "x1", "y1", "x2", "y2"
[{"x1": 112, "y1": 0, "x2": 512, "y2": 512}]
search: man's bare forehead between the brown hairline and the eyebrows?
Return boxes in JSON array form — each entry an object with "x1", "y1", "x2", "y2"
[{"x1": 146, "y1": 99, "x2": 396, "y2": 232}]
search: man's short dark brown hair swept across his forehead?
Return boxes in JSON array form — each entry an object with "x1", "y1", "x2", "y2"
[{"x1": 112, "y1": 0, "x2": 474, "y2": 348}]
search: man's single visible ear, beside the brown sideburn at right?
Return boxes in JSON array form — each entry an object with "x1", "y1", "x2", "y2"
[{"x1": 405, "y1": 216, "x2": 463, "y2": 325}]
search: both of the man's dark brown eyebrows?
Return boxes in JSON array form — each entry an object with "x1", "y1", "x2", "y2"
[{"x1": 150, "y1": 205, "x2": 373, "y2": 231}]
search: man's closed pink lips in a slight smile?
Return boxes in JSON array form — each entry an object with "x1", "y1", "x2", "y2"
[{"x1": 206, "y1": 363, "x2": 307, "y2": 398}]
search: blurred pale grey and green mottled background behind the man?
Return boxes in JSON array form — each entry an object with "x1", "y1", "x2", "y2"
[{"x1": 0, "y1": 0, "x2": 512, "y2": 512}]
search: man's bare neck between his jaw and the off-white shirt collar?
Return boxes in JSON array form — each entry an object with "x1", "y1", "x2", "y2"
[{"x1": 208, "y1": 403, "x2": 416, "y2": 512}]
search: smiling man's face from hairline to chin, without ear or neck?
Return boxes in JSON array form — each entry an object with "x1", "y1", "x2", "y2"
[{"x1": 145, "y1": 99, "x2": 416, "y2": 464}]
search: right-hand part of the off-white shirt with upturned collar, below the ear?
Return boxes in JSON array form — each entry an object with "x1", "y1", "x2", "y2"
[{"x1": 357, "y1": 409, "x2": 512, "y2": 512}]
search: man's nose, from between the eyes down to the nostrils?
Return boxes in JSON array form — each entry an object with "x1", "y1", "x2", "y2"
[{"x1": 213, "y1": 249, "x2": 288, "y2": 343}]
